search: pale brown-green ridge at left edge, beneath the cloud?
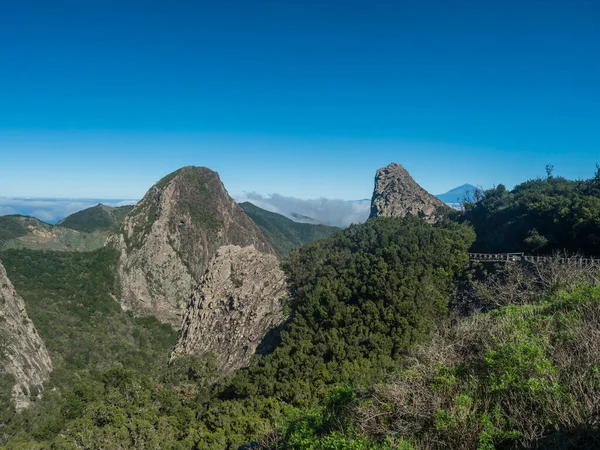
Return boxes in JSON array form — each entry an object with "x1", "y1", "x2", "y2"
[{"x1": 0, "y1": 215, "x2": 108, "y2": 251}]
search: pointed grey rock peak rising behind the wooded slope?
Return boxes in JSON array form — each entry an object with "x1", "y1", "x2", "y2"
[{"x1": 369, "y1": 163, "x2": 450, "y2": 223}]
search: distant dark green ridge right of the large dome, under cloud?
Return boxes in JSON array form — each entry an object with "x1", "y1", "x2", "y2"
[{"x1": 240, "y1": 202, "x2": 339, "y2": 257}]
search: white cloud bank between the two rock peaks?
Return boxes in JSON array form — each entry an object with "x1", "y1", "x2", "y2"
[{"x1": 236, "y1": 192, "x2": 371, "y2": 227}]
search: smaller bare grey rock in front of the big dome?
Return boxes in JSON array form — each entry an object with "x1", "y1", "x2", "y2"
[{"x1": 171, "y1": 245, "x2": 287, "y2": 374}]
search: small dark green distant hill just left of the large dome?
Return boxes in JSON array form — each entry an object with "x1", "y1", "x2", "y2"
[{"x1": 56, "y1": 203, "x2": 133, "y2": 233}]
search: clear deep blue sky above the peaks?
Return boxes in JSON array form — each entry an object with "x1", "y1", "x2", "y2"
[{"x1": 0, "y1": 0, "x2": 600, "y2": 199}]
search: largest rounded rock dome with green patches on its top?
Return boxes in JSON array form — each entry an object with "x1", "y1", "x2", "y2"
[{"x1": 107, "y1": 166, "x2": 273, "y2": 326}]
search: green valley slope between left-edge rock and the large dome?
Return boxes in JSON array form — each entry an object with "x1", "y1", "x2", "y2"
[{"x1": 0, "y1": 249, "x2": 176, "y2": 448}]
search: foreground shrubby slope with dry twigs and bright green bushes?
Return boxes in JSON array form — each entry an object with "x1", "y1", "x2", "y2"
[{"x1": 271, "y1": 270, "x2": 600, "y2": 450}]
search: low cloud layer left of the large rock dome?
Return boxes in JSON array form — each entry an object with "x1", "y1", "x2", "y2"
[{"x1": 0, "y1": 197, "x2": 136, "y2": 224}]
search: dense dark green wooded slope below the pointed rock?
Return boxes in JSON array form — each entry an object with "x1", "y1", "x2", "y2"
[{"x1": 233, "y1": 217, "x2": 473, "y2": 406}]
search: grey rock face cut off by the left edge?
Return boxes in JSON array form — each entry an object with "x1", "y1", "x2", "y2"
[{"x1": 0, "y1": 264, "x2": 52, "y2": 411}]
